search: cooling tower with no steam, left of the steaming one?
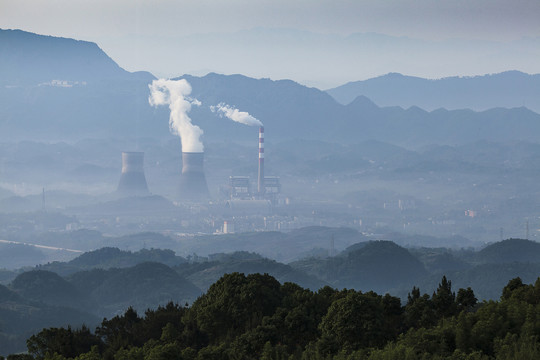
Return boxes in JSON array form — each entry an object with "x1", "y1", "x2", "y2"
[{"x1": 117, "y1": 151, "x2": 150, "y2": 196}]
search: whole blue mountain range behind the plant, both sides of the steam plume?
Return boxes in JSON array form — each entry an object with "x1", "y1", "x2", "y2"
[{"x1": 0, "y1": 30, "x2": 540, "y2": 146}]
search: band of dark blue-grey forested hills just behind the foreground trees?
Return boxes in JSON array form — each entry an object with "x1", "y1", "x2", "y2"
[{"x1": 5, "y1": 239, "x2": 540, "y2": 354}]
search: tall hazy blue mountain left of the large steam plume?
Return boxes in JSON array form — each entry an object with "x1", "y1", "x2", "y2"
[{"x1": 0, "y1": 30, "x2": 160, "y2": 140}]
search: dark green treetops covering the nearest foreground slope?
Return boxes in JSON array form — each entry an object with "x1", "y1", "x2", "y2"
[{"x1": 8, "y1": 273, "x2": 540, "y2": 360}]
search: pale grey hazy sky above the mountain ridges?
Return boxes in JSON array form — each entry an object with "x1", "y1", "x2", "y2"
[{"x1": 0, "y1": 0, "x2": 540, "y2": 88}]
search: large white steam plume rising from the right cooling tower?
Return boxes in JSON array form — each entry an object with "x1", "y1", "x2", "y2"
[{"x1": 148, "y1": 79, "x2": 204, "y2": 152}]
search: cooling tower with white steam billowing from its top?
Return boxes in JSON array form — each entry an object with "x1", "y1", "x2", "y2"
[{"x1": 178, "y1": 152, "x2": 210, "y2": 201}]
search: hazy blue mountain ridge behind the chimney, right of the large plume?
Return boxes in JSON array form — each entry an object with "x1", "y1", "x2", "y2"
[{"x1": 178, "y1": 74, "x2": 540, "y2": 146}]
